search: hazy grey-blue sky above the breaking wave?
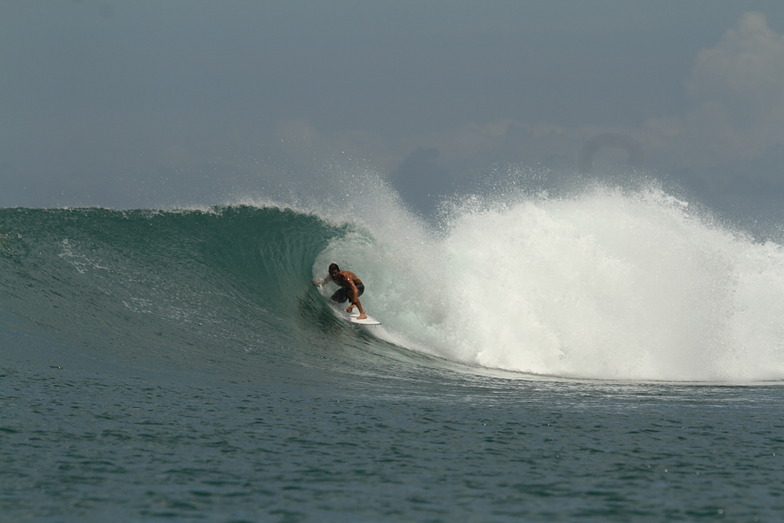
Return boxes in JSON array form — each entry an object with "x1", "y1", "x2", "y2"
[{"x1": 0, "y1": 0, "x2": 784, "y2": 223}]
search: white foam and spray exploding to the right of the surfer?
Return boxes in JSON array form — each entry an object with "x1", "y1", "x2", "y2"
[{"x1": 316, "y1": 176, "x2": 784, "y2": 381}]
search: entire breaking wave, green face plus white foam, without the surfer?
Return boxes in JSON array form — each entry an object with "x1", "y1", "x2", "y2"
[{"x1": 0, "y1": 189, "x2": 784, "y2": 381}]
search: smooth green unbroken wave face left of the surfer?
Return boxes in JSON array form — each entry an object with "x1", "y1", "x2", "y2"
[{"x1": 0, "y1": 207, "x2": 341, "y2": 380}]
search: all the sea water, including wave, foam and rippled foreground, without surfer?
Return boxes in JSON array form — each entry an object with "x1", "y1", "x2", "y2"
[{"x1": 0, "y1": 183, "x2": 784, "y2": 522}]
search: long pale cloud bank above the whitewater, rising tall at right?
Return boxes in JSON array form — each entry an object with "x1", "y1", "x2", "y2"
[{"x1": 264, "y1": 12, "x2": 784, "y2": 219}]
